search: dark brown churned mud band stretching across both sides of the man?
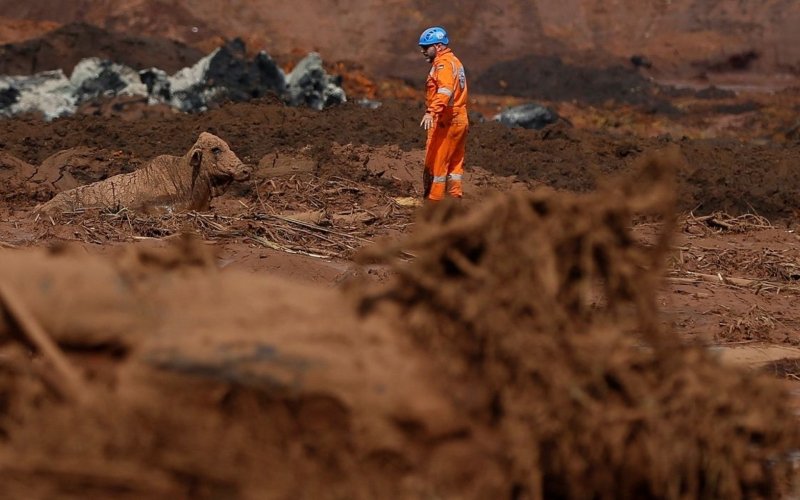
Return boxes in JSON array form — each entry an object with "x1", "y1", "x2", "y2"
[{"x1": 0, "y1": 99, "x2": 800, "y2": 222}]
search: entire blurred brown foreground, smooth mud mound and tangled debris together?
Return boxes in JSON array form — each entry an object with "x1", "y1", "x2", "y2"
[{"x1": 0, "y1": 150, "x2": 800, "y2": 498}]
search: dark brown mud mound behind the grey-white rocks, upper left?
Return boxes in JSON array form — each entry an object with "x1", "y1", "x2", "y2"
[{"x1": 0, "y1": 23, "x2": 205, "y2": 75}]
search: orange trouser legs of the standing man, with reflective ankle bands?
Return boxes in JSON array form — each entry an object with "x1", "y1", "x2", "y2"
[{"x1": 424, "y1": 113, "x2": 468, "y2": 200}]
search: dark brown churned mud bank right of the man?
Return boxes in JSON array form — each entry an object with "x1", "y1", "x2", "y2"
[{"x1": 467, "y1": 119, "x2": 800, "y2": 223}]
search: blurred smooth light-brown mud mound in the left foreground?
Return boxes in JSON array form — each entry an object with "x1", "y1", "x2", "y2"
[{"x1": 0, "y1": 242, "x2": 456, "y2": 498}]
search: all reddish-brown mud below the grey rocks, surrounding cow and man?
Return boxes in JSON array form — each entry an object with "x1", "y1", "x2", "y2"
[{"x1": 0, "y1": 15, "x2": 800, "y2": 498}]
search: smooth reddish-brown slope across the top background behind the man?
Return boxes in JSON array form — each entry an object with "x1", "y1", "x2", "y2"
[{"x1": 0, "y1": 0, "x2": 800, "y2": 78}]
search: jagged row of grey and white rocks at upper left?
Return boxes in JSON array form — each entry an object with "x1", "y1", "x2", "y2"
[{"x1": 0, "y1": 39, "x2": 347, "y2": 119}]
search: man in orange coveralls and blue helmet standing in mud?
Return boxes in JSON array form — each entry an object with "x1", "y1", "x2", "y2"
[{"x1": 419, "y1": 26, "x2": 469, "y2": 202}]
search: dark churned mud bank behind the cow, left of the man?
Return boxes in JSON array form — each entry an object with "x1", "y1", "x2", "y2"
[{"x1": 0, "y1": 98, "x2": 425, "y2": 163}]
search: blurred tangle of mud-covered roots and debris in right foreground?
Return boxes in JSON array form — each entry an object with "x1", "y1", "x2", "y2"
[{"x1": 362, "y1": 146, "x2": 798, "y2": 498}]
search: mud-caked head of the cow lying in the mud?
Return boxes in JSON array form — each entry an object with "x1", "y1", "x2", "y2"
[{"x1": 189, "y1": 132, "x2": 250, "y2": 196}]
